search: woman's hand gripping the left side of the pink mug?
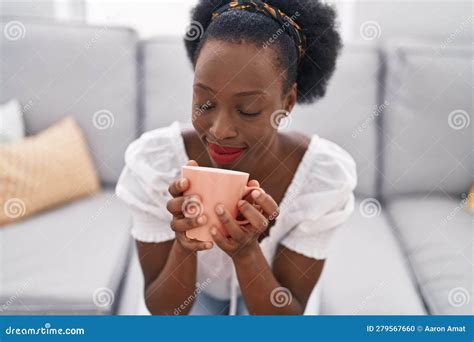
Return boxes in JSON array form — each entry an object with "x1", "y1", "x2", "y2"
[{"x1": 166, "y1": 160, "x2": 213, "y2": 252}]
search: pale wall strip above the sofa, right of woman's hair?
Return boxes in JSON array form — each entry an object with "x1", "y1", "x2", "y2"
[{"x1": 343, "y1": 0, "x2": 474, "y2": 44}]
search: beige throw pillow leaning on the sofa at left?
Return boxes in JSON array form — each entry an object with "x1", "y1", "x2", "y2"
[{"x1": 0, "y1": 117, "x2": 100, "y2": 226}]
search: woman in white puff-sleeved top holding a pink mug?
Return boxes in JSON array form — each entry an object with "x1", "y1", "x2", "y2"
[{"x1": 117, "y1": 0, "x2": 356, "y2": 315}]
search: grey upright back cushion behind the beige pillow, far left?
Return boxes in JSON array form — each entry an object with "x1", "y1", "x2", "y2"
[{"x1": 0, "y1": 19, "x2": 138, "y2": 183}]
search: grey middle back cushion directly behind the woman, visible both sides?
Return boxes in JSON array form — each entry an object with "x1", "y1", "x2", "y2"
[{"x1": 142, "y1": 37, "x2": 380, "y2": 195}]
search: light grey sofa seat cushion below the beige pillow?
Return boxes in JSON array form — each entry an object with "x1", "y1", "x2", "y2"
[{"x1": 0, "y1": 190, "x2": 131, "y2": 315}]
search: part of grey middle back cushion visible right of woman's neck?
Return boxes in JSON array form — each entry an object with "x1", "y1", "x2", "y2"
[{"x1": 290, "y1": 44, "x2": 382, "y2": 196}]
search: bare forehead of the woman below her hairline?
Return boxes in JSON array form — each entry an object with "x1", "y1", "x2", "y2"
[{"x1": 195, "y1": 39, "x2": 282, "y2": 91}]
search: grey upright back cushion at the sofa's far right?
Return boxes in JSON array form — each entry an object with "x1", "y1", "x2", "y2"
[{"x1": 381, "y1": 42, "x2": 474, "y2": 197}]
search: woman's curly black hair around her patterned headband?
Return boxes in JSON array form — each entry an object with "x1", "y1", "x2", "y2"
[{"x1": 184, "y1": 0, "x2": 342, "y2": 103}]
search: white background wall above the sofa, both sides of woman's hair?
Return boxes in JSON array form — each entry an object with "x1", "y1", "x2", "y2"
[{"x1": 0, "y1": 0, "x2": 474, "y2": 44}]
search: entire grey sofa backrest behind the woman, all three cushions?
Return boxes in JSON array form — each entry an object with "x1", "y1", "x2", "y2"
[{"x1": 4, "y1": 18, "x2": 474, "y2": 196}]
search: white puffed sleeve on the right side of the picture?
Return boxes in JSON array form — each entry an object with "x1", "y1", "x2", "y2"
[{"x1": 280, "y1": 138, "x2": 357, "y2": 259}]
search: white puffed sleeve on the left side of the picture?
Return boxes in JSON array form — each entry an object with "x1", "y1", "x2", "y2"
[{"x1": 115, "y1": 122, "x2": 187, "y2": 242}]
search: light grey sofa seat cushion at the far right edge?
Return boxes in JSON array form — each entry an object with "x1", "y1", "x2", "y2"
[{"x1": 387, "y1": 195, "x2": 474, "y2": 315}]
